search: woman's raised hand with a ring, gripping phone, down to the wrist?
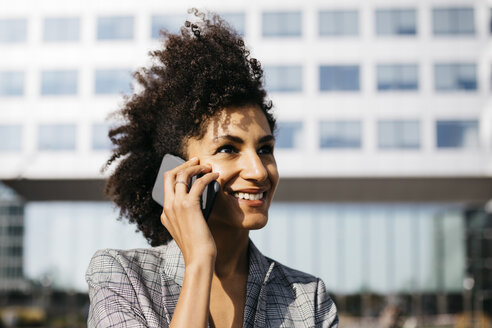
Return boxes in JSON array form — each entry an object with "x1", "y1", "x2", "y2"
[{"x1": 161, "y1": 158, "x2": 219, "y2": 265}]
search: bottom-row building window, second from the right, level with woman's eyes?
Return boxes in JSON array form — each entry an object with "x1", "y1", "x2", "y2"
[{"x1": 378, "y1": 120, "x2": 420, "y2": 149}]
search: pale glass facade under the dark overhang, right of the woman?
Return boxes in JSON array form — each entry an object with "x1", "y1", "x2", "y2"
[{"x1": 251, "y1": 202, "x2": 466, "y2": 294}]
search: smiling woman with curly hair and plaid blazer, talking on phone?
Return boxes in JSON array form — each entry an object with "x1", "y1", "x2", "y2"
[{"x1": 86, "y1": 11, "x2": 338, "y2": 327}]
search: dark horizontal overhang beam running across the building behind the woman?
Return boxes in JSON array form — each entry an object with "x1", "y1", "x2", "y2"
[{"x1": 3, "y1": 177, "x2": 492, "y2": 204}]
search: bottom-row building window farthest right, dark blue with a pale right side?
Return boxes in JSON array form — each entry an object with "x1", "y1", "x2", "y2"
[{"x1": 436, "y1": 120, "x2": 479, "y2": 149}]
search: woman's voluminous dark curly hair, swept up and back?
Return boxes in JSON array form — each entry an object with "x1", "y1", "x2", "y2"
[{"x1": 105, "y1": 9, "x2": 275, "y2": 246}]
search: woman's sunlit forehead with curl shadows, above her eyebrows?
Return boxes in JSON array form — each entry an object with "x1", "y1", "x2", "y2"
[{"x1": 204, "y1": 105, "x2": 272, "y2": 138}]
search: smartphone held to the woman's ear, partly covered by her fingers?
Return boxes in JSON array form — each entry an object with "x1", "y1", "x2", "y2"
[{"x1": 152, "y1": 154, "x2": 220, "y2": 221}]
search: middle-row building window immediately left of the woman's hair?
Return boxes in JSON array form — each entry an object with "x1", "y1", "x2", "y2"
[{"x1": 94, "y1": 69, "x2": 132, "y2": 95}]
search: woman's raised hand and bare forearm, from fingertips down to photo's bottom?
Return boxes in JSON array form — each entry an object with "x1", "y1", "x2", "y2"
[{"x1": 161, "y1": 158, "x2": 219, "y2": 327}]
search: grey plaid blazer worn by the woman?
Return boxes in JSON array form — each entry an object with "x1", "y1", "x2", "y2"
[{"x1": 86, "y1": 241, "x2": 338, "y2": 327}]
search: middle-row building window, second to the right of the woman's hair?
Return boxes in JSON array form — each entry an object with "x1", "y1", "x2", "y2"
[{"x1": 319, "y1": 65, "x2": 360, "y2": 91}]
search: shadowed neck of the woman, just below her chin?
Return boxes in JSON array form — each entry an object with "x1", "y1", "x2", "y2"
[{"x1": 211, "y1": 227, "x2": 249, "y2": 278}]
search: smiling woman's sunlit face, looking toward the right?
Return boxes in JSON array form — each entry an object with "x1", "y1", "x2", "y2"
[{"x1": 187, "y1": 105, "x2": 278, "y2": 229}]
